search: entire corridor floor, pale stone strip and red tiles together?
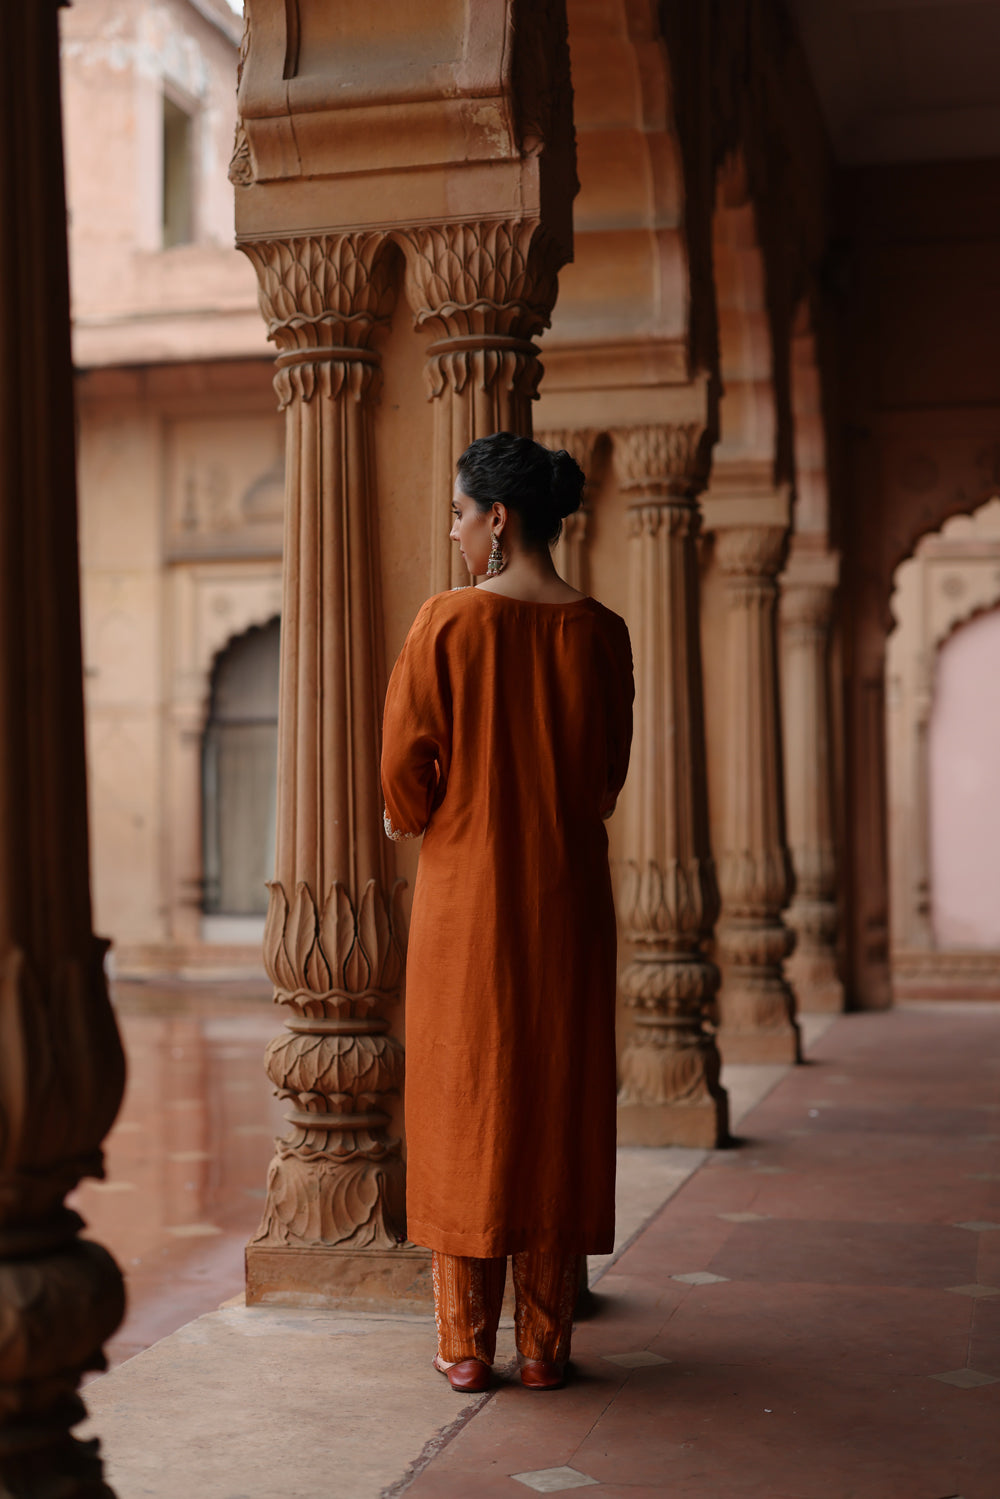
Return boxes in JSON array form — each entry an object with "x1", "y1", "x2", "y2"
[{"x1": 81, "y1": 1004, "x2": 1000, "y2": 1499}]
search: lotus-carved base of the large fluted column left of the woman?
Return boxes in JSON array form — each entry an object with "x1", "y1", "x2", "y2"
[{"x1": 246, "y1": 880, "x2": 432, "y2": 1310}]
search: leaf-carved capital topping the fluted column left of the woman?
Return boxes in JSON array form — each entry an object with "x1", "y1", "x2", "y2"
[{"x1": 240, "y1": 231, "x2": 394, "y2": 408}]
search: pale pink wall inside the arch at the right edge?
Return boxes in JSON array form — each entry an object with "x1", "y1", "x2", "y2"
[{"x1": 930, "y1": 609, "x2": 1000, "y2": 949}]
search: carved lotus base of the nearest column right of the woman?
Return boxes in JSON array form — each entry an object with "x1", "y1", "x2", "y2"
[{"x1": 618, "y1": 950, "x2": 729, "y2": 1150}]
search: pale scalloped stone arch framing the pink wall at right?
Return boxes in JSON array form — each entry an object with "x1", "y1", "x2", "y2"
[{"x1": 886, "y1": 492, "x2": 1000, "y2": 992}]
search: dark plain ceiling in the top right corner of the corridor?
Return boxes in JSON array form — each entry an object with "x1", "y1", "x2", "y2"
[{"x1": 787, "y1": 0, "x2": 1000, "y2": 166}]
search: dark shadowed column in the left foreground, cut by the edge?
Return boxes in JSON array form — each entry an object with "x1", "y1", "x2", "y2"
[{"x1": 0, "y1": 0, "x2": 124, "y2": 1499}]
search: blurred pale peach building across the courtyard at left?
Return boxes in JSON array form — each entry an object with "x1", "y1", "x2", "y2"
[{"x1": 61, "y1": 0, "x2": 283, "y2": 977}]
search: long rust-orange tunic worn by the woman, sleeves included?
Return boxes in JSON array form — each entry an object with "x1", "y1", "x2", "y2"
[{"x1": 382, "y1": 588, "x2": 633, "y2": 1258}]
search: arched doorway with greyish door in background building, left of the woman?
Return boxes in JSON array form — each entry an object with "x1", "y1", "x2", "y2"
[{"x1": 202, "y1": 619, "x2": 279, "y2": 941}]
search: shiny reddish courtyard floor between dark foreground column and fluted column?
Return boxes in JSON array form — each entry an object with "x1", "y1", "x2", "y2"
[{"x1": 69, "y1": 983, "x2": 286, "y2": 1364}]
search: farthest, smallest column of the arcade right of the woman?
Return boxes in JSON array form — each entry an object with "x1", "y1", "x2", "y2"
[{"x1": 781, "y1": 553, "x2": 844, "y2": 1013}]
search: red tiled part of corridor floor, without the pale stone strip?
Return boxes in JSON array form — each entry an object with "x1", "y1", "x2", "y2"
[{"x1": 408, "y1": 1006, "x2": 1000, "y2": 1499}]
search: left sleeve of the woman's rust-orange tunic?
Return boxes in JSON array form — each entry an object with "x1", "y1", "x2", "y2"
[{"x1": 382, "y1": 604, "x2": 451, "y2": 839}]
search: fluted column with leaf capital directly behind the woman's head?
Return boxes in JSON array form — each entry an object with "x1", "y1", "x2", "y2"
[{"x1": 397, "y1": 219, "x2": 565, "y2": 594}]
